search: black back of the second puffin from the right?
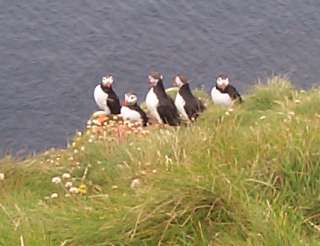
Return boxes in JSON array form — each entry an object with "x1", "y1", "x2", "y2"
[{"x1": 179, "y1": 83, "x2": 205, "y2": 120}]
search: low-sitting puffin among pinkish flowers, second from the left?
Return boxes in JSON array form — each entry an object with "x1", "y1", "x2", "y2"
[{"x1": 121, "y1": 92, "x2": 148, "y2": 126}]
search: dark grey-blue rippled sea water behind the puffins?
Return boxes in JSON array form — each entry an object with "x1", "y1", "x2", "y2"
[{"x1": 0, "y1": 0, "x2": 320, "y2": 155}]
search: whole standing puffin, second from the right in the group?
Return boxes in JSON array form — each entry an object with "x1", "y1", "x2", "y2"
[{"x1": 173, "y1": 74, "x2": 205, "y2": 121}]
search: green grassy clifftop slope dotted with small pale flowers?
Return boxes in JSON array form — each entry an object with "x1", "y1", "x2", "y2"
[{"x1": 0, "y1": 77, "x2": 320, "y2": 245}]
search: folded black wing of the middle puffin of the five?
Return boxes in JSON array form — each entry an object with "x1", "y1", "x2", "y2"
[{"x1": 157, "y1": 96, "x2": 180, "y2": 126}]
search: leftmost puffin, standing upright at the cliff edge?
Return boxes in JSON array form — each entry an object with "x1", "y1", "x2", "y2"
[{"x1": 94, "y1": 75, "x2": 121, "y2": 115}]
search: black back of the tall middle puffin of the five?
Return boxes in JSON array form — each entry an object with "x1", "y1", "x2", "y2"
[{"x1": 153, "y1": 80, "x2": 180, "y2": 126}]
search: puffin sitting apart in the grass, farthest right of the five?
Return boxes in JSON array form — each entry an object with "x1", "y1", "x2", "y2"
[{"x1": 211, "y1": 74, "x2": 242, "y2": 107}]
